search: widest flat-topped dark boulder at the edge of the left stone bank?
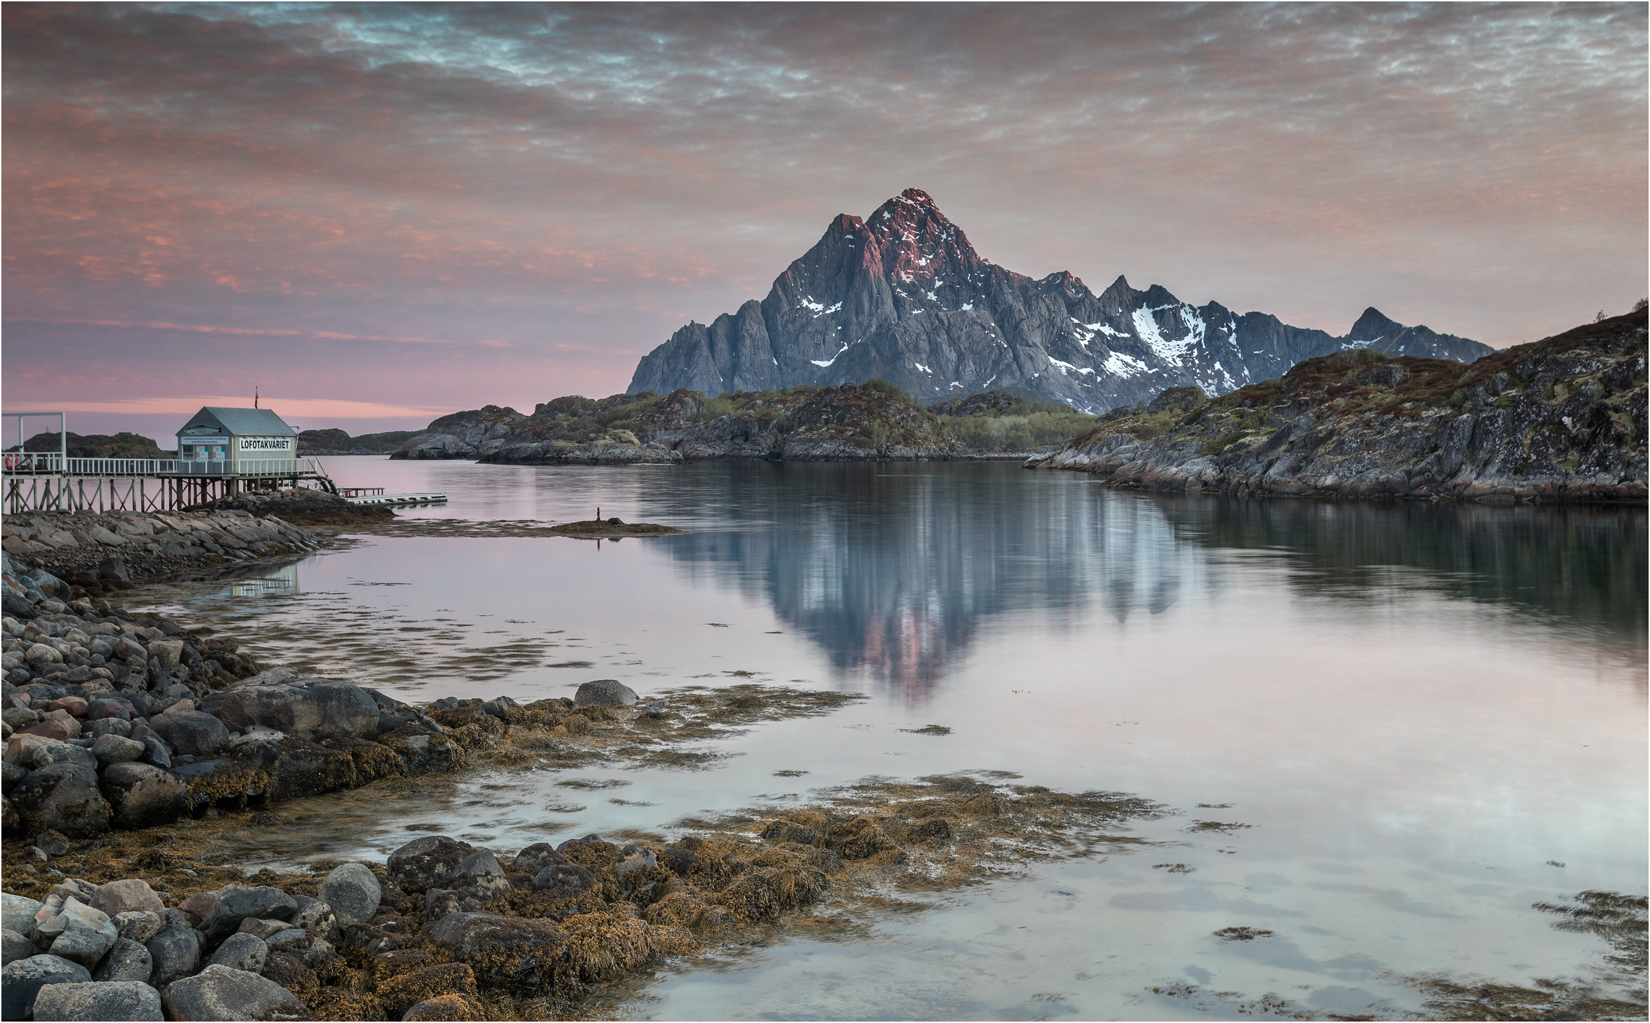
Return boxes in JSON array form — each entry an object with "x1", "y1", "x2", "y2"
[{"x1": 218, "y1": 670, "x2": 380, "y2": 741}]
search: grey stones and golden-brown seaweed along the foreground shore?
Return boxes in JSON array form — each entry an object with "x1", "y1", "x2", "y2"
[{"x1": 0, "y1": 528, "x2": 1645, "y2": 1020}]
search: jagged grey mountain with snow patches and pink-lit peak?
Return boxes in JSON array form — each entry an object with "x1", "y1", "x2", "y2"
[{"x1": 629, "y1": 188, "x2": 1492, "y2": 413}]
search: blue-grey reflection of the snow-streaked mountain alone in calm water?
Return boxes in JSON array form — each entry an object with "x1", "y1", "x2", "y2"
[{"x1": 643, "y1": 465, "x2": 1200, "y2": 700}]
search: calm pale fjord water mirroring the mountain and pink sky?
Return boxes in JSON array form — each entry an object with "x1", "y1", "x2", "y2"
[{"x1": 148, "y1": 459, "x2": 1650, "y2": 1018}]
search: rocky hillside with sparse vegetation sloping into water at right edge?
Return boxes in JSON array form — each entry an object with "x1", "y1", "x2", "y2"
[{"x1": 1028, "y1": 310, "x2": 1647, "y2": 502}]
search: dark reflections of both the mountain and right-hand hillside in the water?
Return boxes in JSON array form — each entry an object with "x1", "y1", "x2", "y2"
[{"x1": 636, "y1": 464, "x2": 1647, "y2": 701}]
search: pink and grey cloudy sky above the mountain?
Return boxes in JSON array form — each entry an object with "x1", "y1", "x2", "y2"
[{"x1": 0, "y1": 3, "x2": 1650, "y2": 446}]
